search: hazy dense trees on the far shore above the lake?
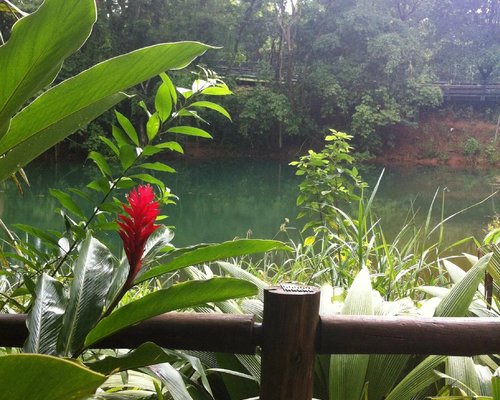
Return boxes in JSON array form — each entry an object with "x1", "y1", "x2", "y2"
[{"x1": 0, "y1": 0, "x2": 500, "y2": 151}]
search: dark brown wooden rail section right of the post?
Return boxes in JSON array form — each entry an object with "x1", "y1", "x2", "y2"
[{"x1": 317, "y1": 315, "x2": 500, "y2": 356}]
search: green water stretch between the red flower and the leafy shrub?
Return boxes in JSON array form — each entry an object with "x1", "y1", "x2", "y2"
[{"x1": 167, "y1": 160, "x2": 298, "y2": 244}]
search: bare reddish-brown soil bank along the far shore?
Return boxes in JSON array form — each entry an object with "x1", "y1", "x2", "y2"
[{"x1": 182, "y1": 113, "x2": 500, "y2": 168}]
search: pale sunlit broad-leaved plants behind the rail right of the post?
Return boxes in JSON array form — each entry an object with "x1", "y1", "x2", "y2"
[{"x1": 219, "y1": 254, "x2": 500, "y2": 400}]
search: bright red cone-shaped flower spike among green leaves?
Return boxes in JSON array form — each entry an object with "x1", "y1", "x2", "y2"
[{"x1": 118, "y1": 185, "x2": 160, "y2": 288}]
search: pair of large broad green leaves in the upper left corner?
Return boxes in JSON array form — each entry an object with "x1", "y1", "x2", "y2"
[{"x1": 0, "y1": 0, "x2": 209, "y2": 181}]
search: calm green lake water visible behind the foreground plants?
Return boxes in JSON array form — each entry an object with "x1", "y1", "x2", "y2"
[{"x1": 0, "y1": 159, "x2": 500, "y2": 252}]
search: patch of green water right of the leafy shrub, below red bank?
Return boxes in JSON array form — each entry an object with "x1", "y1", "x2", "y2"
[{"x1": 367, "y1": 167, "x2": 500, "y2": 244}]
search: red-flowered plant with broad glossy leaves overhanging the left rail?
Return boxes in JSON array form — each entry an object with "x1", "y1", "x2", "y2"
[{"x1": 0, "y1": 180, "x2": 286, "y2": 399}]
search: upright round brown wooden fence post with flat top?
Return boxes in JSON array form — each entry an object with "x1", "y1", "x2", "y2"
[{"x1": 260, "y1": 284, "x2": 320, "y2": 400}]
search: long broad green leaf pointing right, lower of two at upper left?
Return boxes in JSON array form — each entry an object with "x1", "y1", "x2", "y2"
[{"x1": 0, "y1": 42, "x2": 209, "y2": 181}]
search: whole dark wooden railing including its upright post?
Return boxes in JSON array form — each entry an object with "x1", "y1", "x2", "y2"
[{"x1": 0, "y1": 285, "x2": 500, "y2": 400}]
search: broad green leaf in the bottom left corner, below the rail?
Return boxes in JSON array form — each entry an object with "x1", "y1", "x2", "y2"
[{"x1": 0, "y1": 354, "x2": 106, "y2": 400}]
